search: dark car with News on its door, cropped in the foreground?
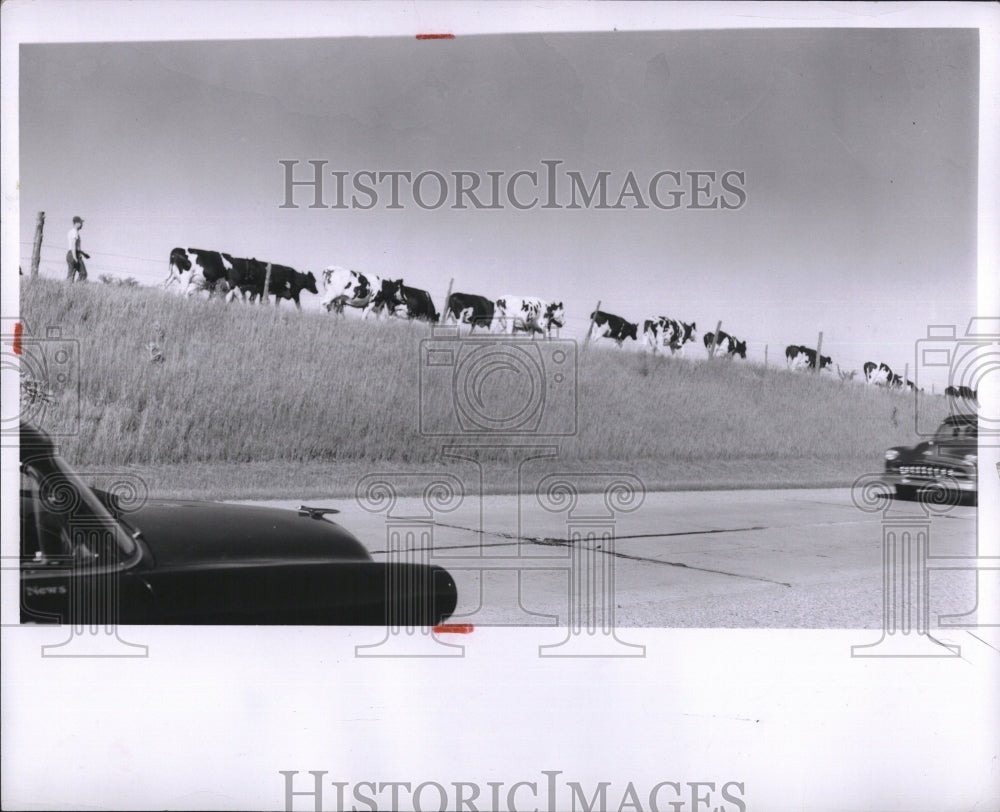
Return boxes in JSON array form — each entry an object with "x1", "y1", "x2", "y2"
[{"x1": 21, "y1": 425, "x2": 458, "y2": 626}]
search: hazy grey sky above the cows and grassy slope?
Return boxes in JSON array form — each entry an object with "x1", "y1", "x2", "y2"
[{"x1": 20, "y1": 29, "x2": 979, "y2": 372}]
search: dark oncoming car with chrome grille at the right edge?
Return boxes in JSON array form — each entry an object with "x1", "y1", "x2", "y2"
[{"x1": 884, "y1": 414, "x2": 978, "y2": 501}]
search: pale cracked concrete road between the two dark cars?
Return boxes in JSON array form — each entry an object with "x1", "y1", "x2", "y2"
[{"x1": 236, "y1": 489, "x2": 976, "y2": 629}]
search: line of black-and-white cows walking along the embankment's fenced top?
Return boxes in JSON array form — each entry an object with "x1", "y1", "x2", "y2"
[{"x1": 164, "y1": 248, "x2": 975, "y2": 398}]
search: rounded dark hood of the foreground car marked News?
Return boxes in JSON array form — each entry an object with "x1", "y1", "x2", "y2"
[{"x1": 122, "y1": 500, "x2": 371, "y2": 569}]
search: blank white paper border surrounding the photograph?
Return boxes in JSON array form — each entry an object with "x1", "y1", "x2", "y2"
[{"x1": 0, "y1": 0, "x2": 1000, "y2": 810}]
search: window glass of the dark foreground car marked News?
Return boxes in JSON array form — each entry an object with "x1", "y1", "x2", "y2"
[{"x1": 21, "y1": 455, "x2": 138, "y2": 565}]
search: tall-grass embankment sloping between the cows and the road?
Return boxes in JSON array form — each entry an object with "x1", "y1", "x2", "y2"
[{"x1": 21, "y1": 279, "x2": 947, "y2": 498}]
